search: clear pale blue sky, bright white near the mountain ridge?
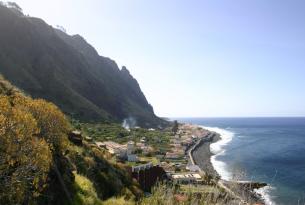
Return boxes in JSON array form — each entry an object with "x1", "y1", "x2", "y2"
[{"x1": 15, "y1": 0, "x2": 305, "y2": 117}]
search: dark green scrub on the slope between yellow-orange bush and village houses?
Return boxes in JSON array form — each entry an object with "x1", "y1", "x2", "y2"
[{"x1": 67, "y1": 139, "x2": 142, "y2": 199}]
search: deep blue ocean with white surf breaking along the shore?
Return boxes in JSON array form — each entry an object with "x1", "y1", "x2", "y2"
[{"x1": 177, "y1": 118, "x2": 305, "y2": 205}]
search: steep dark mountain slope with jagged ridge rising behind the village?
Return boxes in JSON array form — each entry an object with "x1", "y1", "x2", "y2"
[{"x1": 0, "y1": 5, "x2": 166, "y2": 127}]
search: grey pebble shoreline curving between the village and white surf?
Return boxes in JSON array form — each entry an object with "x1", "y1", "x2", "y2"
[{"x1": 186, "y1": 125, "x2": 267, "y2": 204}]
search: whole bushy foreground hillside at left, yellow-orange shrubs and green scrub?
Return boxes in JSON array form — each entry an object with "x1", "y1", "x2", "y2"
[{"x1": 0, "y1": 78, "x2": 142, "y2": 205}]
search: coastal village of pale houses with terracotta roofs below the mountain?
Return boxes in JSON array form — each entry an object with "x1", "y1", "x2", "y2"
[{"x1": 69, "y1": 124, "x2": 209, "y2": 191}]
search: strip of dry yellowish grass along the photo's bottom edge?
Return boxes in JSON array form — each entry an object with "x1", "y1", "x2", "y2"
[{"x1": 69, "y1": 173, "x2": 245, "y2": 205}]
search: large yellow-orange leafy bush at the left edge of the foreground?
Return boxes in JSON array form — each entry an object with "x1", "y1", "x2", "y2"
[{"x1": 0, "y1": 77, "x2": 69, "y2": 204}]
